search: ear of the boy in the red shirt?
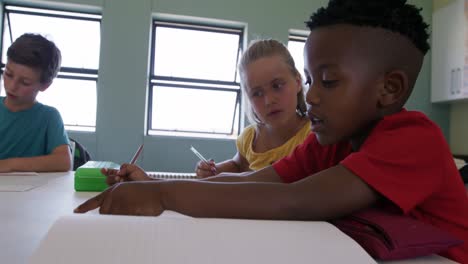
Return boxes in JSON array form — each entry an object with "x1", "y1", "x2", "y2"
[{"x1": 378, "y1": 70, "x2": 409, "y2": 108}]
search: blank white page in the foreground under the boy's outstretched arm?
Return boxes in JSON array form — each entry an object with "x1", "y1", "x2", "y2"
[{"x1": 30, "y1": 214, "x2": 375, "y2": 264}]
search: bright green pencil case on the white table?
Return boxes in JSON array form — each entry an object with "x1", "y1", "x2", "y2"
[{"x1": 75, "y1": 160, "x2": 120, "y2": 192}]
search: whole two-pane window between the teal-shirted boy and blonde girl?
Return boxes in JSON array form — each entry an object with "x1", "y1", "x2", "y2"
[{"x1": 148, "y1": 20, "x2": 243, "y2": 138}]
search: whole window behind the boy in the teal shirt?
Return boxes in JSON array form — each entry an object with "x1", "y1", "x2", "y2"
[{"x1": 1, "y1": 5, "x2": 101, "y2": 131}]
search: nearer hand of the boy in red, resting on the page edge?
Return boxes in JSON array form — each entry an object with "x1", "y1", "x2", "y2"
[{"x1": 74, "y1": 182, "x2": 164, "y2": 216}]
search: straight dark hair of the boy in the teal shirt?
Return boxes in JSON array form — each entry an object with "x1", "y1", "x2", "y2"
[{"x1": 7, "y1": 33, "x2": 62, "y2": 83}]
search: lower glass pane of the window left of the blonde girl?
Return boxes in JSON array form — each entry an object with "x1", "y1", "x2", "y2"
[{"x1": 152, "y1": 86, "x2": 238, "y2": 135}]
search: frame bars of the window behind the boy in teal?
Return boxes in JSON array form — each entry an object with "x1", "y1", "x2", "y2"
[{"x1": 0, "y1": 3, "x2": 102, "y2": 132}]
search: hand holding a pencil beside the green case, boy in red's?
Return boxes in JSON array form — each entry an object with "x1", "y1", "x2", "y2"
[{"x1": 101, "y1": 164, "x2": 152, "y2": 186}]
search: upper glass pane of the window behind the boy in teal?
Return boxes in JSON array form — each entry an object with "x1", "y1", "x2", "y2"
[{"x1": 2, "y1": 9, "x2": 100, "y2": 69}]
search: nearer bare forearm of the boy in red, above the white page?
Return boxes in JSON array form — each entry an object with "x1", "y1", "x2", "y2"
[{"x1": 159, "y1": 165, "x2": 379, "y2": 221}]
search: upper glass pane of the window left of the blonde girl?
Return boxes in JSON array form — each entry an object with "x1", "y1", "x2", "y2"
[{"x1": 154, "y1": 26, "x2": 240, "y2": 82}]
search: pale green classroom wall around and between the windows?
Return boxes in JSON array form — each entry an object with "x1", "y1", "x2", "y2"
[{"x1": 0, "y1": 0, "x2": 449, "y2": 171}]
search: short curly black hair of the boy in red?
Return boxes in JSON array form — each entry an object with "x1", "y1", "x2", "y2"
[{"x1": 305, "y1": 0, "x2": 429, "y2": 54}]
